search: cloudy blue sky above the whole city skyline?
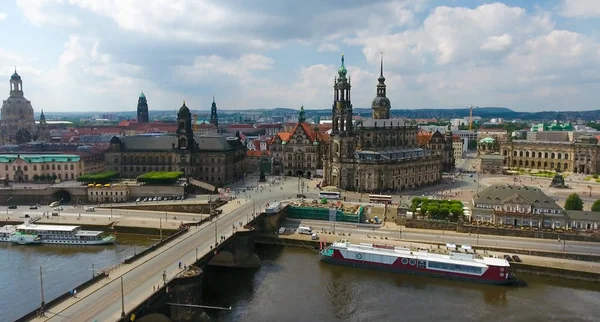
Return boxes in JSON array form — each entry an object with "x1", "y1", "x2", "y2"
[{"x1": 0, "y1": 0, "x2": 600, "y2": 112}]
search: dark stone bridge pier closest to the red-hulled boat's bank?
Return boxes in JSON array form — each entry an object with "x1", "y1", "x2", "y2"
[{"x1": 208, "y1": 231, "x2": 260, "y2": 268}]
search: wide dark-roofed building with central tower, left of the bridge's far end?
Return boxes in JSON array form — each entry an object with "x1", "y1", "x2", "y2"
[{"x1": 105, "y1": 102, "x2": 246, "y2": 186}]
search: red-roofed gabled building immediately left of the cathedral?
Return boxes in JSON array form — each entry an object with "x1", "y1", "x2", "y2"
[{"x1": 271, "y1": 106, "x2": 329, "y2": 177}]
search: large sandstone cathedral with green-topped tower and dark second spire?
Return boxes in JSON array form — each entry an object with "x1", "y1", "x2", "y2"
[{"x1": 323, "y1": 55, "x2": 453, "y2": 193}]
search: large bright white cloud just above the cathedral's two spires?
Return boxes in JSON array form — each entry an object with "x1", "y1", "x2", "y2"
[{"x1": 349, "y1": 3, "x2": 552, "y2": 68}]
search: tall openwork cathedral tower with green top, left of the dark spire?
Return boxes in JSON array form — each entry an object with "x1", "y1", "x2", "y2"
[{"x1": 331, "y1": 55, "x2": 352, "y2": 136}]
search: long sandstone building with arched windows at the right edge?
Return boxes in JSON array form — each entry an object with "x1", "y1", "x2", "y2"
[{"x1": 499, "y1": 135, "x2": 600, "y2": 174}]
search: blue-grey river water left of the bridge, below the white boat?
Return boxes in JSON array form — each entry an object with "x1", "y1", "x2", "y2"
[{"x1": 0, "y1": 234, "x2": 157, "y2": 321}]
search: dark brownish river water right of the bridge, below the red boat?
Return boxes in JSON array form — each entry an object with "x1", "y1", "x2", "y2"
[{"x1": 203, "y1": 245, "x2": 600, "y2": 322}]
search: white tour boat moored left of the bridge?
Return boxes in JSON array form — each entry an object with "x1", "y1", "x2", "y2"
[{"x1": 0, "y1": 221, "x2": 115, "y2": 245}]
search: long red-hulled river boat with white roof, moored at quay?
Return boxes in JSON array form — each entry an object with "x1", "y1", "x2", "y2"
[{"x1": 320, "y1": 240, "x2": 524, "y2": 285}]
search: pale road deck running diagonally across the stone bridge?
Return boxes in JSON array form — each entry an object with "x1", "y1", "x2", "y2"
[{"x1": 35, "y1": 179, "x2": 297, "y2": 322}]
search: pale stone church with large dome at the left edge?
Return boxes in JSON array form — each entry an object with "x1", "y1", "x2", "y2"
[{"x1": 0, "y1": 69, "x2": 48, "y2": 144}]
